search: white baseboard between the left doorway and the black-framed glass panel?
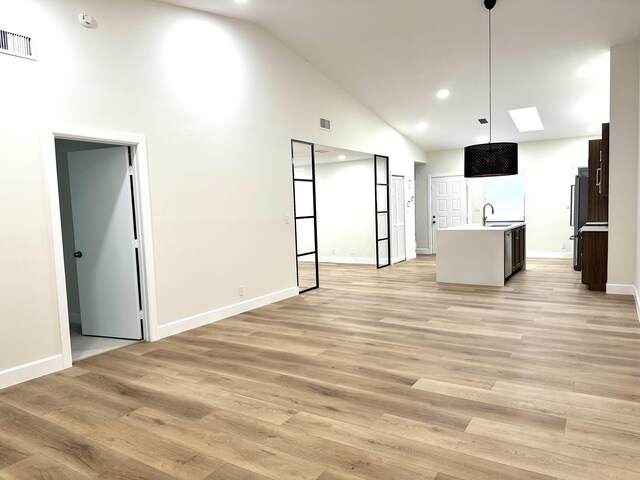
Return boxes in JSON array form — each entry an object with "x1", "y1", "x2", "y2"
[{"x1": 155, "y1": 287, "x2": 299, "y2": 340}]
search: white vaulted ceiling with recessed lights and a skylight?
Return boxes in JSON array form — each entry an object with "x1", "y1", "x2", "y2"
[{"x1": 155, "y1": 0, "x2": 640, "y2": 151}]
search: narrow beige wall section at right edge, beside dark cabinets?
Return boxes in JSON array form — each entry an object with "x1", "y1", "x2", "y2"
[{"x1": 607, "y1": 40, "x2": 640, "y2": 294}]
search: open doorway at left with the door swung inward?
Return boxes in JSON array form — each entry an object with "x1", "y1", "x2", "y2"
[{"x1": 55, "y1": 139, "x2": 144, "y2": 361}]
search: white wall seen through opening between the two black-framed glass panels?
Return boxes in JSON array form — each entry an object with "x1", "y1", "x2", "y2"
[{"x1": 316, "y1": 157, "x2": 376, "y2": 264}]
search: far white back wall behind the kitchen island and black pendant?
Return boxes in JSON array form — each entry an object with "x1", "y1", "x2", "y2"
[{"x1": 416, "y1": 137, "x2": 592, "y2": 258}]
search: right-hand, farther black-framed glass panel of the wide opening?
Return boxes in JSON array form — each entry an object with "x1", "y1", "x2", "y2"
[{"x1": 373, "y1": 155, "x2": 391, "y2": 268}]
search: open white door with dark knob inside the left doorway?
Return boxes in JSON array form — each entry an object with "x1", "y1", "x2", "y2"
[{"x1": 68, "y1": 147, "x2": 142, "y2": 340}]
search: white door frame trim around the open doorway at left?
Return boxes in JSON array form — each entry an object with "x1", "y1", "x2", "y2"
[{"x1": 42, "y1": 125, "x2": 159, "y2": 368}]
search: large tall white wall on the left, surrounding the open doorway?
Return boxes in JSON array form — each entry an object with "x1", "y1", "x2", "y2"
[{"x1": 0, "y1": 0, "x2": 426, "y2": 383}]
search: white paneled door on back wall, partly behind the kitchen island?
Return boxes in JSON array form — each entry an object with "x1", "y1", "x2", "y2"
[{"x1": 431, "y1": 175, "x2": 467, "y2": 253}]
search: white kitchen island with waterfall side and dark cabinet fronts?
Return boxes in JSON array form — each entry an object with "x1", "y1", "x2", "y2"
[{"x1": 436, "y1": 223, "x2": 525, "y2": 286}]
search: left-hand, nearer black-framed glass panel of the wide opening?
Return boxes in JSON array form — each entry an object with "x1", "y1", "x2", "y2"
[{"x1": 291, "y1": 140, "x2": 319, "y2": 293}]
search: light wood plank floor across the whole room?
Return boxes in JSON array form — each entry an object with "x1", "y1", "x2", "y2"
[{"x1": 0, "y1": 257, "x2": 640, "y2": 480}]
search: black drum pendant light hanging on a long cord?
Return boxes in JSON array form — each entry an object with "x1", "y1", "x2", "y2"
[{"x1": 464, "y1": 0, "x2": 518, "y2": 178}]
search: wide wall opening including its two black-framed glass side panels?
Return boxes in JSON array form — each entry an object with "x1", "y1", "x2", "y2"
[{"x1": 291, "y1": 140, "x2": 391, "y2": 293}]
